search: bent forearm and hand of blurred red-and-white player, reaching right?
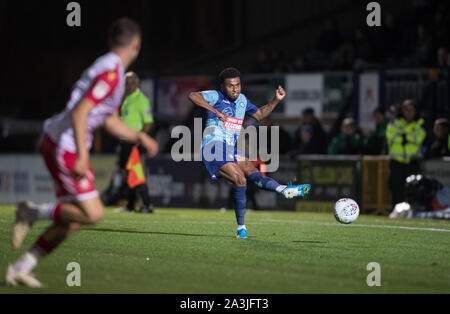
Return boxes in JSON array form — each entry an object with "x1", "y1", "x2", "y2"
[{"x1": 104, "y1": 113, "x2": 159, "y2": 157}]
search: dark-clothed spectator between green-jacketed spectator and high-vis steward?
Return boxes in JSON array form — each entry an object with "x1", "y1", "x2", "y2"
[{"x1": 364, "y1": 107, "x2": 389, "y2": 155}]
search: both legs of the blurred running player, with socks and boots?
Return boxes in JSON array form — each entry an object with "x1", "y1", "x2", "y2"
[{"x1": 6, "y1": 197, "x2": 104, "y2": 288}]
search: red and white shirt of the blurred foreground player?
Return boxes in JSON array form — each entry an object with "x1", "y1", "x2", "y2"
[{"x1": 44, "y1": 52, "x2": 125, "y2": 153}]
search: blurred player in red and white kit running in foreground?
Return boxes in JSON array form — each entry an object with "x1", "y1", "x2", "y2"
[{"x1": 6, "y1": 18, "x2": 158, "y2": 288}]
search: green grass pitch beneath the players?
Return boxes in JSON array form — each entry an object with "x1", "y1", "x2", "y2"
[{"x1": 0, "y1": 206, "x2": 450, "y2": 294}]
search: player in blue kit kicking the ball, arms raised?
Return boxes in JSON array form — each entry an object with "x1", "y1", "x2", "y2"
[{"x1": 189, "y1": 68, "x2": 311, "y2": 239}]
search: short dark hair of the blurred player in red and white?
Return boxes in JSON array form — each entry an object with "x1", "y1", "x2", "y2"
[{"x1": 108, "y1": 17, "x2": 141, "y2": 49}]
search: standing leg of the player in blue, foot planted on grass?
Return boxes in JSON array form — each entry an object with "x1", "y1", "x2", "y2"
[{"x1": 219, "y1": 162, "x2": 247, "y2": 239}]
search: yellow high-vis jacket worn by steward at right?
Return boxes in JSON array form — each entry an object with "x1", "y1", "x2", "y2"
[{"x1": 386, "y1": 118, "x2": 426, "y2": 164}]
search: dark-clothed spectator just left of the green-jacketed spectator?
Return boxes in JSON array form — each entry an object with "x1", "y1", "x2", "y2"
[{"x1": 292, "y1": 108, "x2": 328, "y2": 156}]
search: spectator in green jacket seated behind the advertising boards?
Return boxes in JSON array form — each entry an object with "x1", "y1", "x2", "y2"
[{"x1": 328, "y1": 118, "x2": 364, "y2": 155}]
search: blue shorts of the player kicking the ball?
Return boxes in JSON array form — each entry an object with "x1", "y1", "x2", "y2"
[{"x1": 202, "y1": 141, "x2": 248, "y2": 180}]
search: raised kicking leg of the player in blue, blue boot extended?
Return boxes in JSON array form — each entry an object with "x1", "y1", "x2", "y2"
[{"x1": 237, "y1": 157, "x2": 311, "y2": 199}]
